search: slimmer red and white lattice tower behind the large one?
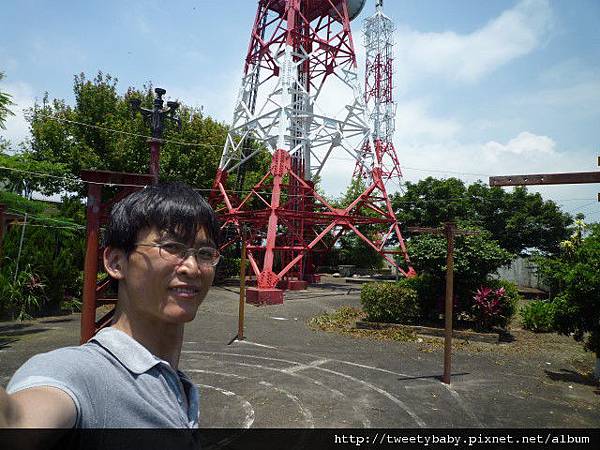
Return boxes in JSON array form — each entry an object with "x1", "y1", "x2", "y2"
[{"x1": 355, "y1": 0, "x2": 402, "y2": 187}]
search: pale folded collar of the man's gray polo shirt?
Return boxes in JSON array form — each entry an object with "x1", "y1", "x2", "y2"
[{"x1": 90, "y1": 327, "x2": 169, "y2": 375}]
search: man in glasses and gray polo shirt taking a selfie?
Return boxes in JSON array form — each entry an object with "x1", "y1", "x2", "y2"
[{"x1": 0, "y1": 183, "x2": 220, "y2": 428}]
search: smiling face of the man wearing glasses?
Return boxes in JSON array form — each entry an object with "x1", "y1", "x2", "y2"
[{"x1": 119, "y1": 228, "x2": 215, "y2": 323}]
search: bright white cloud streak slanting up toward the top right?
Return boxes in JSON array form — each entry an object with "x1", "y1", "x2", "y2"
[{"x1": 396, "y1": 0, "x2": 553, "y2": 85}]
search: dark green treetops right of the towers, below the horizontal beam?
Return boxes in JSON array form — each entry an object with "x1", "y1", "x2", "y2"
[{"x1": 392, "y1": 177, "x2": 573, "y2": 253}]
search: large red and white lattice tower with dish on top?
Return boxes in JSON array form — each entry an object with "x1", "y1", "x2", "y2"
[{"x1": 210, "y1": 0, "x2": 414, "y2": 304}]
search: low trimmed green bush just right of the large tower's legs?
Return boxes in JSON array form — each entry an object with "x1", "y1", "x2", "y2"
[{"x1": 360, "y1": 280, "x2": 420, "y2": 324}]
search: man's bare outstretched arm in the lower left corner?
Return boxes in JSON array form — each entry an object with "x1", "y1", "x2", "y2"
[{"x1": 0, "y1": 386, "x2": 77, "y2": 428}]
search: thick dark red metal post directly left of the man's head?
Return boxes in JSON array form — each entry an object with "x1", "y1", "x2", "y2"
[{"x1": 80, "y1": 184, "x2": 102, "y2": 344}]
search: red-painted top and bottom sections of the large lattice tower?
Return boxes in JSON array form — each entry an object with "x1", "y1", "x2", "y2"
[{"x1": 210, "y1": 0, "x2": 414, "y2": 304}]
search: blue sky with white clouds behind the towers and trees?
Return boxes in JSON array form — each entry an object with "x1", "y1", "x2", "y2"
[{"x1": 0, "y1": 0, "x2": 600, "y2": 221}]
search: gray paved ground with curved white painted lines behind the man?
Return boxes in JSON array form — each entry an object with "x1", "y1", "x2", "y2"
[{"x1": 0, "y1": 285, "x2": 600, "y2": 428}]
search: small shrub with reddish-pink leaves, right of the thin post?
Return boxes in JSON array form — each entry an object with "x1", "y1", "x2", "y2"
[{"x1": 471, "y1": 280, "x2": 520, "y2": 330}]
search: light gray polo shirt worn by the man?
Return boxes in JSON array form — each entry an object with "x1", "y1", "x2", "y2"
[{"x1": 6, "y1": 328, "x2": 198, "y2": 428}]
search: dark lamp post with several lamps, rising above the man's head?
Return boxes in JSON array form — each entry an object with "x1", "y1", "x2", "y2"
[{"x1": 130, "y1": 88, "x2": 181, "y2": 183}]
